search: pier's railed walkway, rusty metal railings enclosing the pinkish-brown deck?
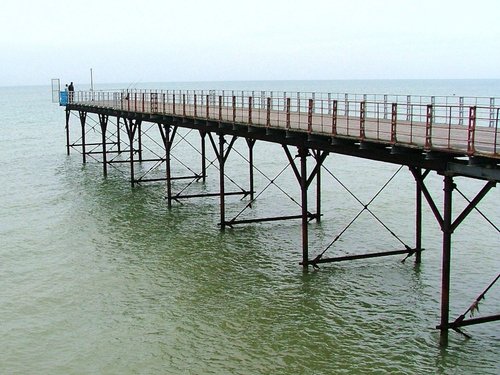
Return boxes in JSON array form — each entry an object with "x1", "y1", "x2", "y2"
[{"x1": 70, "y1": 90, "x2": 500, "y2": 158}]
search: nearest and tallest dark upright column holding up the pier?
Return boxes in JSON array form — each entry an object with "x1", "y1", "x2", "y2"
[{"x1": 440, "y1": 176, "x2": 454, "y2": 346}]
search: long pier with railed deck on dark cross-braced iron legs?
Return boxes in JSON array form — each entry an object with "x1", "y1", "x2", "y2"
[{"x1": 56, "y1": 86, "x2": 500, "y2": 344}]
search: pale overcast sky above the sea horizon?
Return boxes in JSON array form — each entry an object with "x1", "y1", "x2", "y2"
[{"x1": 0, "y1": 0, "x2": 500, "y2": 86}]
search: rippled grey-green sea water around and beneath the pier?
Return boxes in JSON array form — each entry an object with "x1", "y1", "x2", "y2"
[{"x1": 0, "y1": 80, "x2": 500, "y2": 374}]
